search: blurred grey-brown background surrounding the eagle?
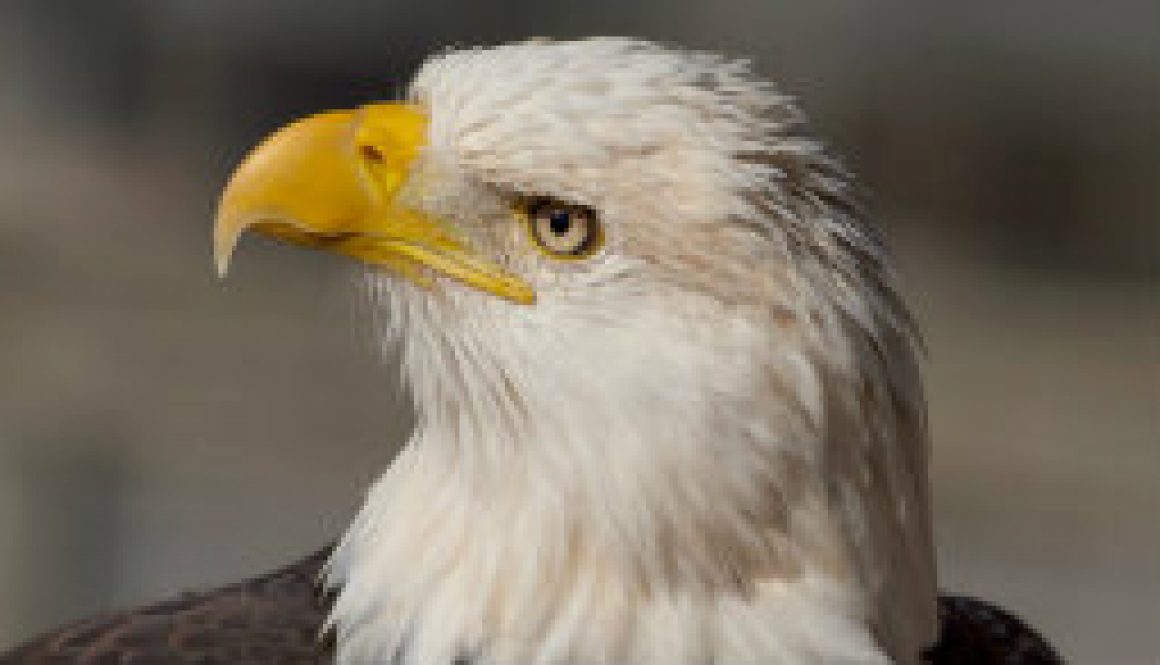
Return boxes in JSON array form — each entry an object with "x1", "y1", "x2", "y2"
[{"x1": 0, "y1": 0, "x2": 1160, "y2": 665}]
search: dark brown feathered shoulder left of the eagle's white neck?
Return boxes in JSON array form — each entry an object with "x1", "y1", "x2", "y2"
[{"x1": 0, "y1": 550, "x2": 333, "y2": 665}]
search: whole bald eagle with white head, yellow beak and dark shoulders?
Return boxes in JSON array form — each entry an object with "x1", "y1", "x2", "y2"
[{"x1": 0, "y1": 38, "x2": 1058, "y2": 665}]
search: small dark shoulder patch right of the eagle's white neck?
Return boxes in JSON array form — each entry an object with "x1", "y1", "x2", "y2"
[{"x1": 926, "y1": 595, "x2": 1064, "y2": 665}]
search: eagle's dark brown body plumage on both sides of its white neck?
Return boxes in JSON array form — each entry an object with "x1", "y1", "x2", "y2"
[{"x1": 0, "y1": 549, "x2": 1063, "y2": 665}]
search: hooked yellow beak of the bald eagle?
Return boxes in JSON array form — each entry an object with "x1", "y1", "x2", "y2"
[{"x1": 213, "y1": 103, "x2": 536, "y2": 304}]
